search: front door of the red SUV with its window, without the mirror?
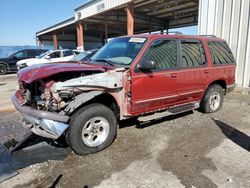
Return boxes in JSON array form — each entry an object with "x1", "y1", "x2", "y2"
[{"x1": 132, "y1": 39, "x2": 178, "y2": 114}]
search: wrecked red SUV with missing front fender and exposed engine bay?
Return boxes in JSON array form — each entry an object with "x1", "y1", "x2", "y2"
[{"x1": 12, "y1": 34, "x2": 236, "y2": 155}]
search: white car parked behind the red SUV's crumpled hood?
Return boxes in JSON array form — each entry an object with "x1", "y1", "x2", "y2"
[{"x1": 16, "y1": 50, "x2": 76, "y2": 70}]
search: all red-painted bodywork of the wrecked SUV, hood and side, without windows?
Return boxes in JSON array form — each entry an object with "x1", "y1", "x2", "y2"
[{"x1": 18, "y1": 35, "x2": 236, "y2": 116}]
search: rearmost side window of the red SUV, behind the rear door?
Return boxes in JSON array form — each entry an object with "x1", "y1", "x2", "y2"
[{"x1": 208, "y1": 42, "x2": 235, "y2": 65}]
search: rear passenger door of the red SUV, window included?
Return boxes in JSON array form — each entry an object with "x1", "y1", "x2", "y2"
[{"x1": 178, "y1": 39, "x2": 210, "y2": 103}]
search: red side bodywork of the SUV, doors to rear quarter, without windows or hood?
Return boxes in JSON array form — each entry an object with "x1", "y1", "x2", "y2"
[{"x1": 128, "y1": 35, "x2": 236, "y2": 116}]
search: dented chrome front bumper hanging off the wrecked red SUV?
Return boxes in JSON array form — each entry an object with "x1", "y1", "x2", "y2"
[{"x1": 12, "y1": 96, "x2": 69, "y2": 139}]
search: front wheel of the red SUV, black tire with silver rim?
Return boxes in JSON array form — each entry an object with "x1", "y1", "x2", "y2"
[{"x1": 66, "y1": 104, "x2": 117, "y2": 155}]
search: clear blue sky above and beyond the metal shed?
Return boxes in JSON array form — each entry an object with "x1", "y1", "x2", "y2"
[{"x1": 0, "y1": 0, "x2": 197, "y2": 46}]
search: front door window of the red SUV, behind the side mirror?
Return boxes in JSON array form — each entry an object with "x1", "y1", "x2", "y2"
[{"x1": 143, "y1": 40, "x2": 177, "y2": 70}]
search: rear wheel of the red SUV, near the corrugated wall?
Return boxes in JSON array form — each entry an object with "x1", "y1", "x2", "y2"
[{"x1": 200, "y1": 84, "x2": 225, "y2": 113}]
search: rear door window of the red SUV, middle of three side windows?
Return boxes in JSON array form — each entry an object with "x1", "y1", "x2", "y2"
[{"x1": 180, "y1": 40, "x2": 206, "y2": 68}]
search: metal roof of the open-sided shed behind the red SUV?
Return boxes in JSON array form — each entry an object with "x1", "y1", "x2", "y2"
[{"x1": 37, "y1": 0, "x2": 199, "y2": 37}]
